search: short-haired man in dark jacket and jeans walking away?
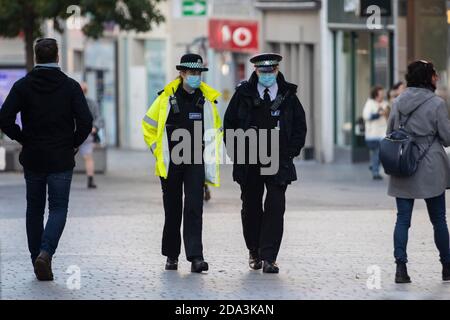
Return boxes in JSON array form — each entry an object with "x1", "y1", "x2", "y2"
[{"x1": 0, "y1": 38, "x2": 92, "y2": 281}]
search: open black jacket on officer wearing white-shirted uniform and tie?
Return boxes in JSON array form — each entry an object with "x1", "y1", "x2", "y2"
[{"x1": 224, "y1": 72, "x2": 307, "y2": 185}]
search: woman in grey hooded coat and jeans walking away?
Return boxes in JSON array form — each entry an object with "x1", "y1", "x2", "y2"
[{"x1": 387, "y1": 60, "x2": 450, "y2": 283}]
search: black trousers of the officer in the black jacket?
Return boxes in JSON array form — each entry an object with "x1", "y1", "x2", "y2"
[{"x1": 241, "y1": 166, "x2": 287, "y2": 261}]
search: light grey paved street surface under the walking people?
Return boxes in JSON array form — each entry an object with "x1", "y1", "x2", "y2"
[{"x1": 0, "y1": 150, "x2": 450, "y2": 299}]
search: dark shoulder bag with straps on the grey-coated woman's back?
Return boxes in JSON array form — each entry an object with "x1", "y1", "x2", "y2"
[{"x1": 380, "y1": 101, "x2": 437, "y2": 177}]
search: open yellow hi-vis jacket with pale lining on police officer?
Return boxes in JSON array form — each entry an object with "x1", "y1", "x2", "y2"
[{"x1": 142, "y1": 78, "x2": 223, "y2": 187}]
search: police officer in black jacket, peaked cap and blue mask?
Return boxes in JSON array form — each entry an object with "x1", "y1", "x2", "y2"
[{"x1": 224, "y1": 54, "x2": 307, "y2": 273}]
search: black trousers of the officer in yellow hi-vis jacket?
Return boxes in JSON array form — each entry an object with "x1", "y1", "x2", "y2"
[{"x1": 161, "y1": 164, "x2": 205, "y2": 261}]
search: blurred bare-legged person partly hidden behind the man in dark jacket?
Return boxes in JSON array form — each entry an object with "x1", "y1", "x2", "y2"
[{"x1": 80, "y1": 83, "x2": 104, "y2": 189}]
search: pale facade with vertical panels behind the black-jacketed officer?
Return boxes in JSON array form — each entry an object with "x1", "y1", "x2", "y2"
[{"x1": 255, "y1": 0, "x2": 327, "y2": 161}]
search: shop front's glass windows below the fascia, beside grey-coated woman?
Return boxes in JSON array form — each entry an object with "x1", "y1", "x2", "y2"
[{"x1": 333, "y1": 30, "x2": 393, "y2": 162}]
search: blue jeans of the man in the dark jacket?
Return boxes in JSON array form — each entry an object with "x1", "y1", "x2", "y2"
[{"x1": 25, "y1": 170, "x2": 73, "y2": 263}]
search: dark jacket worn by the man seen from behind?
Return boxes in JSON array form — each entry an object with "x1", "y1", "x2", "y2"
[{"x1": 0, "y1": 67, "x2": 92, "y2": 173}]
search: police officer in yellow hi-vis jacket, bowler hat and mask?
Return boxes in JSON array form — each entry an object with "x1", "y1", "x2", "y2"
[{"x1": 142, "y1": 54, "x2": 223, "y2": 273}]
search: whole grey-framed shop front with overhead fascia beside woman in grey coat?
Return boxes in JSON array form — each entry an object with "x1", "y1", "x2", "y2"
[{"x1": 328, "y1": 0, "x2": 395, "y2": 162}]
